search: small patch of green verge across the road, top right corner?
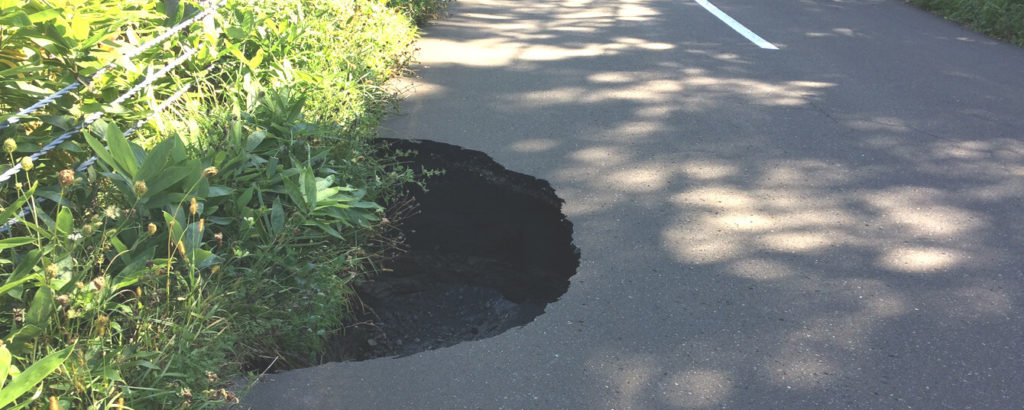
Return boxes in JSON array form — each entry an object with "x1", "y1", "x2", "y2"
[{"x1": 909, "y1": 0, "x2": 1024, "y2": 47}]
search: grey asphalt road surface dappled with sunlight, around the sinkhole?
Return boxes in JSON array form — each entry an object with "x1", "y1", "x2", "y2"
[{"x1": 244, "y1": 0, "x2": 1024, "y2": 409}]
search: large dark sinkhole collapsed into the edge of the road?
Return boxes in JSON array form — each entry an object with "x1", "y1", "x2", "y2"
[{"x1": 329, "y1": 139, "x2": 580, "y2": 361}]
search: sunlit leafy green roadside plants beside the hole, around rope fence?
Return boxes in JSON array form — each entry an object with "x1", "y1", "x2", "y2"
[{"x1": 0, "y1": 0, "x2": 443, "y2": 409}]
